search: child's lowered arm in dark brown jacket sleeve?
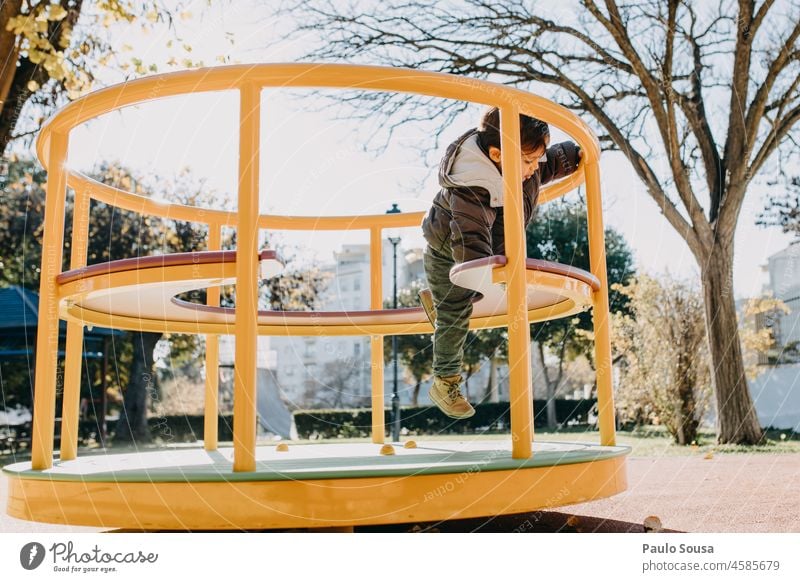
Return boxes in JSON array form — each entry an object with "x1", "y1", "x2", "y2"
[{"x1": 450, "y1": 186, "x2": 497, "y2": 263}]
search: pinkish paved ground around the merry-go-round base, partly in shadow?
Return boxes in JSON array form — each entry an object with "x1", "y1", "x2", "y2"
[{"x1": 0, "y1": 453, "x2": 800, "y2": 533}]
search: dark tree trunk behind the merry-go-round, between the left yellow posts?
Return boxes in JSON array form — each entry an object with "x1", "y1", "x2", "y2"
[{"x1": 114, "y1": 331, "x2": 161, "y2": 443}]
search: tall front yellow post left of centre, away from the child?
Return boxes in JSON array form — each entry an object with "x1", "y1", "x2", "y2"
[{"x1": 233, "y1": 83, "x2": 261, "y2": 471}]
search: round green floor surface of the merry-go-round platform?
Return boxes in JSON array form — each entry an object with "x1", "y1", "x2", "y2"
[{"x1": 3, "y1": 440, "x2": 631, "y2": 483}]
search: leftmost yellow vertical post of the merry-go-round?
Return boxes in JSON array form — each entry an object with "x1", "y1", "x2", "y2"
[{"x1": 31, "y1": 132, "x2": 69, "y2": 471}]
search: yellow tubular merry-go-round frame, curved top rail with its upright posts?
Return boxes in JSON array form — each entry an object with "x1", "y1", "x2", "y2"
[{"x1": 32, "y1": 64, "x2": 615, "y2": 471}]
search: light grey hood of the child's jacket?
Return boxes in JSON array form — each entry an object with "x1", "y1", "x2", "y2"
[{"x1": 439, "y1": 129, "x2": 503, "y2": 208}]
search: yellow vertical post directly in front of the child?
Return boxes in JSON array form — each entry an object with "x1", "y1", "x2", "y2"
[{"x1": 500, "y1": 105, "x2": 533, "y2": 459}]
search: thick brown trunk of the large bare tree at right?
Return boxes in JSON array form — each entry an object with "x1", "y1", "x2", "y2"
[{"x1": 698, "y1": 243, "x2": 763, "y2": 445}]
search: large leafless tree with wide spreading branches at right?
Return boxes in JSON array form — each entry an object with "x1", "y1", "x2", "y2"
[{"x1": 274, "y1": 0, "x2": 800, "y2": 443}]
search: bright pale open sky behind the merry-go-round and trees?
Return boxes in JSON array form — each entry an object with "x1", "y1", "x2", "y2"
[{"x1": 48, "y1": 2, "x2": 792, "y2": 298}]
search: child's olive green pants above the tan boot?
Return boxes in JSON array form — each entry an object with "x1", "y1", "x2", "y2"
[{"x1": 424, "y1": 245, "x2": 475, "y2": 376}]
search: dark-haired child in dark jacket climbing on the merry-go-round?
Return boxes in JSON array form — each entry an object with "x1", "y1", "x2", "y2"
[{"x1": 420, "y1": 107, "x2": 581, "y2": 418}]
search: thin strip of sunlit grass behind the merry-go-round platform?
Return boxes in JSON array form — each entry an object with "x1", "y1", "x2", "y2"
[{"x1": 0, "y1": 426, "x2": 800, "y2": 466}]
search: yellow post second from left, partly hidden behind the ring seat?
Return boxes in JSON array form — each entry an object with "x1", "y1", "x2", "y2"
[{"x1": 61, "y1": 189, "x2": 90, "y2": 461}]
